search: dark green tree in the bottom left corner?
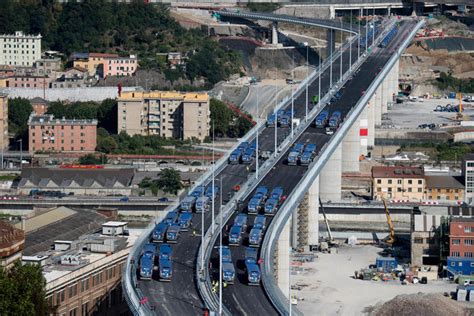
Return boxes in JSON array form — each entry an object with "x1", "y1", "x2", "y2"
[{"x1": 0, "y1": 261, "x2": 49, "y2": 315}]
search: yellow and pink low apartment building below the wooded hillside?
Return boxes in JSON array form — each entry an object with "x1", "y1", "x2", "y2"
[{"x1": 72, "y1": 53, "x2": 138, "y2": 78}]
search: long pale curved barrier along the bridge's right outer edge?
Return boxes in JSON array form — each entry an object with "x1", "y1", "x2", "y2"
[{"x1": 261, "y1": 17, "x2": 424, "y2": 315}]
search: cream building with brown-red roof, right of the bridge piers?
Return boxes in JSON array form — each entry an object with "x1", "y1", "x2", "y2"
[{"x1": 372, "y1": 166, "x2": 425, "y2": 201}]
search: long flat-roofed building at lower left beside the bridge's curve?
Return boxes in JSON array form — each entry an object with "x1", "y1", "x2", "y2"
[{"x1": 22, "y1": 222, "x2": 138, "y2": 316}]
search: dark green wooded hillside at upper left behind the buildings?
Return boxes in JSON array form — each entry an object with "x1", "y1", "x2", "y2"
[{"x1": 0, "y1": 0, "x2": 242, "y2": 83}]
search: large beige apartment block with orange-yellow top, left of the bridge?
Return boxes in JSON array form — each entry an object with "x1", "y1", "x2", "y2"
[{"x1": 117, "y1": 91, "x2": 210, "y2": 141}]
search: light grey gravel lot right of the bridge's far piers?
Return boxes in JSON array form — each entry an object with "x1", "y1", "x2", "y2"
[{"x1": 382, "y1": 99, "x2": 474, "y2": 129}]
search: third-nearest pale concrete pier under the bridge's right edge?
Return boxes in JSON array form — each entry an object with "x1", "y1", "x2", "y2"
[{"x1": 319, "y1": 145, "x2": 342, "y2": 201}]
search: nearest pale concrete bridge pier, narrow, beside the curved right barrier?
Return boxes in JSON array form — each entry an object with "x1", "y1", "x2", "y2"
[{"x1": 277, "y1": 216, "x2": 293, "y2": 297}]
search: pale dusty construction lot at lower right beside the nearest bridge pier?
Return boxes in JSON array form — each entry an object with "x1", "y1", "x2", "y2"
[{"x1": 292, "y1": 245, "x2": 456, "y2": 315}]
